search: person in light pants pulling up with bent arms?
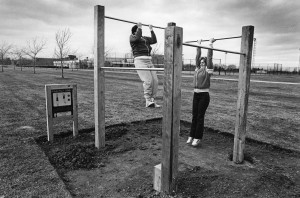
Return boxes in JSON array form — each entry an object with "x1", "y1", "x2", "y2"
[{"x1": 129, "y1": 23, "x2": 161, "y2": 107}]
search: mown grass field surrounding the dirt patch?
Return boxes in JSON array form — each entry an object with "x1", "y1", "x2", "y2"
[{"x1": 0, "y1": 68, "x2": 300, "y2": 197}]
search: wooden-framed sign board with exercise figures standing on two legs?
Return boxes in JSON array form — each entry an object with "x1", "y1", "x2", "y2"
[{"x1": 45, "y1": 84, "x2": 78, "y2": 141}]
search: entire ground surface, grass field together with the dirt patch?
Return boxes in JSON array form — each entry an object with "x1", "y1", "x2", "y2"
[{"x1": 0, "y1": 68, "x2": 300, "y2": 198}]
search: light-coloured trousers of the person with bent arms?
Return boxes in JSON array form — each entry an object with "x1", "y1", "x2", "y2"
[{"x1": 134, "y1": 56, "x2": 158, "y2": 101}]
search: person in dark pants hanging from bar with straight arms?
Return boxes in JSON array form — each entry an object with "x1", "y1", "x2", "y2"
[{"x1": 186, "y1": 38, "x2": 215, "y2": 147}]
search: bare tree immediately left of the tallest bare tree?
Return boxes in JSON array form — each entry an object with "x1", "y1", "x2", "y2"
[{"x1": 24, "y1": 37, "x2": 46, "y2": 74}]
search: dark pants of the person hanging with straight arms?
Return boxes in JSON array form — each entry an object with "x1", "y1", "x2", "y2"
[{"x1": 190, "y1": 92, "x2": 210, "y2": 139}]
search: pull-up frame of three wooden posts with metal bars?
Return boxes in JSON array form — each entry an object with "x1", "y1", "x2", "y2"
[{"x1": 94, "y1": 5, "x2": 254, "y2": 194}]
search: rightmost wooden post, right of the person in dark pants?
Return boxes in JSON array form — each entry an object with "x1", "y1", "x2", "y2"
[{"x1": 233, "y1": 26, "x2": 254, "y2": 164}]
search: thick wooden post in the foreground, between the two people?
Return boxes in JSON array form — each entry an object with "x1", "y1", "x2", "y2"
[{"x1": 161, "y1": 23, "x2": 183, "y2": 194}]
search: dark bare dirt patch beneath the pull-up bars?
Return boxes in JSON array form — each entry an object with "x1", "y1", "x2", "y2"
[{"x1": 36, "y1": 119, "x2": 300, "y2": 197}]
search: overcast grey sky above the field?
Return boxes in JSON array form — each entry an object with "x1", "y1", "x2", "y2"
[{"x1": 0, "y1": 0, "x2": 300, "y2": 67}]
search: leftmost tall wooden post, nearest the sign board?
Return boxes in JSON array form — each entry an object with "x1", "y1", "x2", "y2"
[{"x1": 94, "y1": 5, "x2": 105, "y2": 148}]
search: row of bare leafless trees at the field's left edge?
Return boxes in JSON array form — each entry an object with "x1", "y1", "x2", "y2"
[{"x1": 0, "y1": 28, "x2": 76, "y2": 78}]
